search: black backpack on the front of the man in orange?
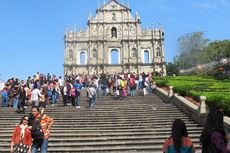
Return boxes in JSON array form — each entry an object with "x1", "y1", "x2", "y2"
[{"x1": 31, "y1": 117, "x2": 44, "y2": 140}]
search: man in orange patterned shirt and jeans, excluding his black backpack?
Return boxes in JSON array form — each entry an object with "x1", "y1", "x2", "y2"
[{"x1": 32, "y1": 107, "x2": 54, "y2": 153}]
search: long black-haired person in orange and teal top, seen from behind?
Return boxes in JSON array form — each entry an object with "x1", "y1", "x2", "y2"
[{"x1": 162, "y1": 119, "x2": 196, "y2": 153}]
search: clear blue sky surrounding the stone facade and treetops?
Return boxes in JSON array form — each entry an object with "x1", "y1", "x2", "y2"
[{"x1": 0, "y1": 0, "x2": 230, "y2": 80}]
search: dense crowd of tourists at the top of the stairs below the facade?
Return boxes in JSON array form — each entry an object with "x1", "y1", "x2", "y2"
[{"x1": 1, "y1": 72, "x2": 154, "y2": 113}]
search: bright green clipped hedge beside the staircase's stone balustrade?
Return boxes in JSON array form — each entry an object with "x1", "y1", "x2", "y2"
[{"x1": 153, "y1": 76, "x2": 230, "y2": 116}]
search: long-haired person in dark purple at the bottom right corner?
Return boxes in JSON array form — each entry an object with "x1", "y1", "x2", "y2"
[{"x1": 200, "y1": 107, "x2": 230, "y2": 153}]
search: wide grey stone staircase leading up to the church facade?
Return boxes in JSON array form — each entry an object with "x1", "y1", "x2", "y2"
[{"x1": 0, "y1": 92, "x2": 202, "y2": 153}]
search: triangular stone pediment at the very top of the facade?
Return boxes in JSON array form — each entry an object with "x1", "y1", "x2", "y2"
[{"x1": 98, "y1": 0, "x2": 130, "y2": 11}]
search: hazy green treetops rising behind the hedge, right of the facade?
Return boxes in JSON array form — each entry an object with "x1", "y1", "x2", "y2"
[{"x1": 174, "y1": 32, "x2": 230, "y2": 69}]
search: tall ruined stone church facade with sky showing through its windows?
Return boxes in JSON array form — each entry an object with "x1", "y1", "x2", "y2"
[{"x1": 64, "y1": 0, "x2": 166, "y2": 75}]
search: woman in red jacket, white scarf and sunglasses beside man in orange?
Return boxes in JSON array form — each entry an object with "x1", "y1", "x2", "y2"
[{"x1": 10, "y1": 116, "x2": 32, "y2": 153}]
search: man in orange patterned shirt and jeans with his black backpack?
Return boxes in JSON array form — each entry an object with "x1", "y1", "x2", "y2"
[{"x1": 31, "y1": 107, "x2": 54, "y2": 153}]
